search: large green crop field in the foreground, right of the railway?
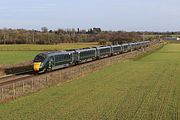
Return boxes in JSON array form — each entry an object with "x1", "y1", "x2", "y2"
[{"x1": 0, "y1": 44, "x2": 180, "y2": 120}]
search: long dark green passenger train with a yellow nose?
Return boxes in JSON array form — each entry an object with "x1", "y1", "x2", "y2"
[{"x1": 33, "y1": 41, "x2": 150, "y2": 73}]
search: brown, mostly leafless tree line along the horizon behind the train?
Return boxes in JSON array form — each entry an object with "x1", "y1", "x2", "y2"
[{"x1": 0, "y1": 27, "x2": 163, "y2": 44}]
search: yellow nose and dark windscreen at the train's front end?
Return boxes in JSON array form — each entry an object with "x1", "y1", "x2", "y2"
[{"x1": 33, "y1": 53, "x2": 46, "y2": 73}]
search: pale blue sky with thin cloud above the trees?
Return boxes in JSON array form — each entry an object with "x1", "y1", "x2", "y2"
[{"x1": 0, "y1": 0, "x2": 180, "y2": 31}]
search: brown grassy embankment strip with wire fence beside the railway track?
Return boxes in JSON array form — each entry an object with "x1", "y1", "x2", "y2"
[{"x1": 0, "y1": 44, "x2": 162, "y2": 102}]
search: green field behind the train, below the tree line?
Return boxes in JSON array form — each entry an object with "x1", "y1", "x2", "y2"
[{"x1": 0, "y1": 43, "x2": 98, "y2": 64}]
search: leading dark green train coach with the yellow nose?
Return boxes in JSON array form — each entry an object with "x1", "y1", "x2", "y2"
[{"x1": 33, "y1": 51, "x2": 76, "y2": 73}]
